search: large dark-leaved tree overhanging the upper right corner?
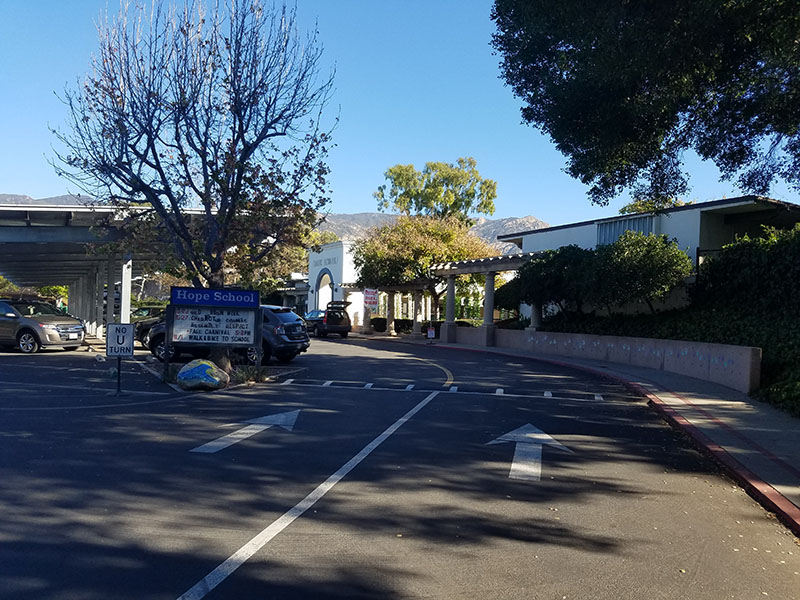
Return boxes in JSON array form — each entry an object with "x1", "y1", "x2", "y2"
[{"x1": 492, "y1": 0, "x2": 800, "y2": 206}]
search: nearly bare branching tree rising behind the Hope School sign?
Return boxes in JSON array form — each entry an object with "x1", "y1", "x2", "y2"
[{"x1": 54, "y1": 0, "x2": 333, "y2": 287}]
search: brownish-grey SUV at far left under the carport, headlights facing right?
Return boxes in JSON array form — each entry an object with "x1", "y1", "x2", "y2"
[{"x1": 0, "y1": 299, "x2": 86, "y2": 354}]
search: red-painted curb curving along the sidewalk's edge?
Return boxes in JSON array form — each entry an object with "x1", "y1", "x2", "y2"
[{"x1": 364, "y1": 338, "x2": 800, "y2": 537}]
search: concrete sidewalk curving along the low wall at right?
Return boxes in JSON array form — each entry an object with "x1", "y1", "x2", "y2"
[{"x1": 360, "y1": 334, "x2": 800, "y2": 536}]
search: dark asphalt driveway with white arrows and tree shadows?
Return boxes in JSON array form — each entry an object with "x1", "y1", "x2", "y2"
[{"x1": 0, "y1": 339, "x2": 800, "y2": 600}]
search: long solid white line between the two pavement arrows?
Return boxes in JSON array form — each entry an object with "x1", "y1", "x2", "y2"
[{"x1": 178, "y1": 392, "x2": 439, "y2": 600}]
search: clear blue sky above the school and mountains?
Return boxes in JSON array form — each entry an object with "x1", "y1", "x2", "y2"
[{"x1": 0, "y1": 0, "x2": 800, "y2": 225}]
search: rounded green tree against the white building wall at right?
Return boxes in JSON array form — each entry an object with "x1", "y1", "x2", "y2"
[{"x1": 593, "y1": 231, "x2": 692, "y2": 313}]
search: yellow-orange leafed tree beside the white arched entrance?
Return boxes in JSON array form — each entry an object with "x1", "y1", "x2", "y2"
[{"x1": 353, "y1": 216, "x2": 497, "y2": 318}]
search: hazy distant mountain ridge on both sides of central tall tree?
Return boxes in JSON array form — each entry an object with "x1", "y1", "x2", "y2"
[{"x1": 319, "y1": 213, "x2": 548, "y2": 254}]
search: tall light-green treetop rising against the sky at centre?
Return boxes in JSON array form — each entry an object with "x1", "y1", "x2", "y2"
[{"x1": 373, "y1": 158, "x2": 497, "y2": 221}]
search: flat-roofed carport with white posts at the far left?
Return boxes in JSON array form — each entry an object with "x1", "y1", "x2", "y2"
[{"x1": 0, "y1": 196, "x2": 159, "y2": 337}]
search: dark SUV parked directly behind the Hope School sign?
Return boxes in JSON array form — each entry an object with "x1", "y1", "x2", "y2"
[{"x1": 147, "y1": 304, "x2": 310, "y2": 364}]
